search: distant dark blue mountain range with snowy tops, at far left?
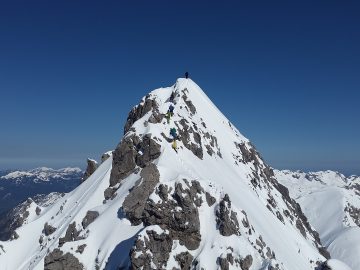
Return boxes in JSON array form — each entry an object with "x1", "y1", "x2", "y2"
[{"x1": 0, "y1": 167, "x2": 83, "y2": 217}]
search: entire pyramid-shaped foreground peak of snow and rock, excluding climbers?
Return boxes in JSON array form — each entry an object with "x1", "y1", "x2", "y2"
[{"x1": 0, "y1": 79, "x2": 336, "y2": 270}]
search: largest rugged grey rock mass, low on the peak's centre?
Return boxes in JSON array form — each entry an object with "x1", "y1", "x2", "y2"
[{"x1": 123, "y1": 179, "x2": 204, "y2": 269}]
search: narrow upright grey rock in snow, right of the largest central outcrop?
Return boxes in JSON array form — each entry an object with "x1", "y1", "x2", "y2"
[{"x1": 216, "y1": 194, "x2": 240, "y2": 236}]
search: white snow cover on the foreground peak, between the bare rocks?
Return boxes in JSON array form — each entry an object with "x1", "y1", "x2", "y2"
[{"x1": 0, "y1": 79, "x2": 330, "y2": 270}]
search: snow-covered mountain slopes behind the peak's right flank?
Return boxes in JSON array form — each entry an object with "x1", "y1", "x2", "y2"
[{"x1": 275, "y1": 170, "x2": 360, "y2": 269}]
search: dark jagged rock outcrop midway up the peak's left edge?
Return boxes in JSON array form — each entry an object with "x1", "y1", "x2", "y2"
[{"x1": 110, "y1": 134, "x2": 161, "y2": 186}]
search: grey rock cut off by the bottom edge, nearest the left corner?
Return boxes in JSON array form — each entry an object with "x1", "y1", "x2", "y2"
[{"x1": 44, "y1": 249, "x2": 84, "y2": 270}]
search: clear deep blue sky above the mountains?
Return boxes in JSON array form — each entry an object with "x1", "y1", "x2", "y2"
[{"x1": 0, "y1": 0, "x2": 360, "y2": 174}]
